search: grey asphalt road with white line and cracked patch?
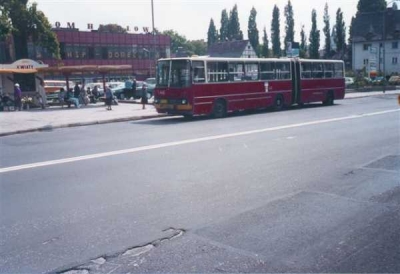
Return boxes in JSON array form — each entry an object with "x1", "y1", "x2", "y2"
[{"x1": 0, "y1": 95, "x2": 400, "y2": 273}]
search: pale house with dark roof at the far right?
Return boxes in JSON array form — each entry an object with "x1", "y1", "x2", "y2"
[{"x1": 352, "y1": 8, "x2": 400, "y2": 75}]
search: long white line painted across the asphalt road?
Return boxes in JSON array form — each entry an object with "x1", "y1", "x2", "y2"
[{"x1": 0, "y1": 109, "x2": 400, "y2": 173}]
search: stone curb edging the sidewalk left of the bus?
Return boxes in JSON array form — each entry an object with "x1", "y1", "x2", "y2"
[{"x1": 0, "y1": 114, "x2": 166, "y2": 137}]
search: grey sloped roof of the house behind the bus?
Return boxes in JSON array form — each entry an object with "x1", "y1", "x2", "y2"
[{"x1": 207, "y1": 40, "x2": 249, "y2": 58}]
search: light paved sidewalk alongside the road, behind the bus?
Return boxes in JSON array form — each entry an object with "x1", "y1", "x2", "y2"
[{"x1": 0, "y1": 90, "x2": 400, "y2": 137}]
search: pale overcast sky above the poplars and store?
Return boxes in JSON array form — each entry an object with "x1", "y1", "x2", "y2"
[{"x1": 36, "y1": 0, "x2": 358, "y2": 40}]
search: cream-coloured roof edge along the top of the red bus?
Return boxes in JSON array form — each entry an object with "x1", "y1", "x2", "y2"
[{"x1": 158, "y1": 56, "x2": 344, "y2": 63}]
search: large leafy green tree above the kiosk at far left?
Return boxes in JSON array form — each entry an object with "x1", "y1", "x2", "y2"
[{"x1": 0, "y1": 0, "x2": 60, "y2": 59}]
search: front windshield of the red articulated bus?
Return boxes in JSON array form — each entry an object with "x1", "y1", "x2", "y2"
[{"x1": 157, "y1": 60, "x2": 190, "y2": 88}]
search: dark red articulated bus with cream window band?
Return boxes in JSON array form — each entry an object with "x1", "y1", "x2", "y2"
[{"x1": 154, "y1": 57, "x2": 345, "y2": 118}]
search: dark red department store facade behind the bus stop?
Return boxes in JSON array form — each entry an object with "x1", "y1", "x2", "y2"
[{"x1": 0, "y1": 28, "x2": 171, "y2": 78}]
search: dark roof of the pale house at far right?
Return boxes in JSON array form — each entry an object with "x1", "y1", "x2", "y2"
[{"x1": 352, "y1": 8, "x2": 400, "y2": 42}]
